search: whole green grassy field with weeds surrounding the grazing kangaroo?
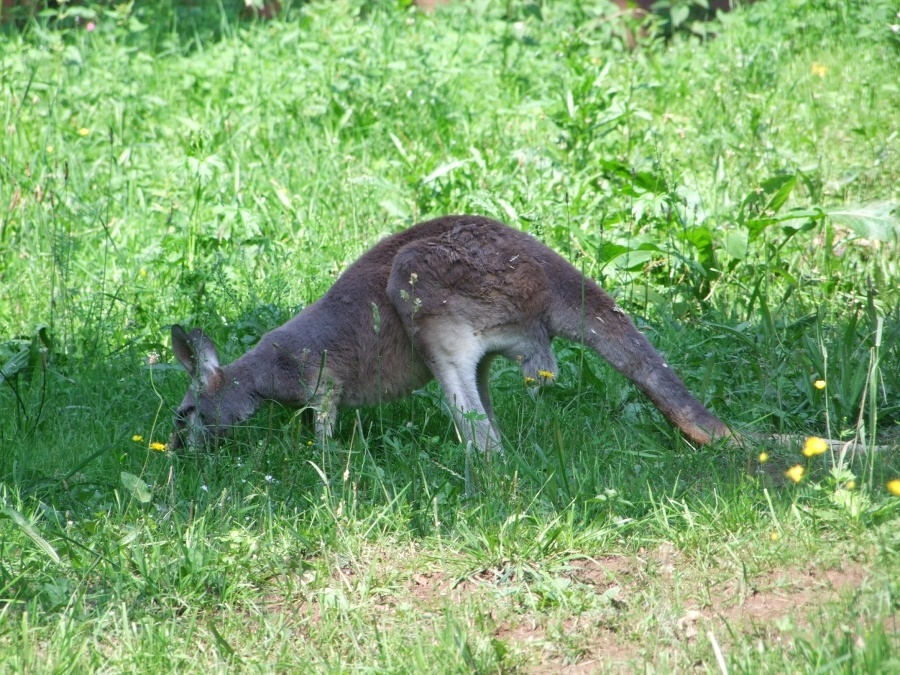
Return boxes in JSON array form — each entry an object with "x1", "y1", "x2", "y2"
[{"x1": 0, "y1": 0, "x2": 900, "y2": 673}]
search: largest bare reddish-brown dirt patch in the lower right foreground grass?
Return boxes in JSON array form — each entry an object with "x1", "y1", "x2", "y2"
[{"x1": 486, "y1": 556, "x2": 870, "y2": 675}]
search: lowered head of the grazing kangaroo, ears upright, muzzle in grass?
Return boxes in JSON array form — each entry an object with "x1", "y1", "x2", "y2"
[{"x1": 169, "y1": 324, "x2": 246, "y2": 450}]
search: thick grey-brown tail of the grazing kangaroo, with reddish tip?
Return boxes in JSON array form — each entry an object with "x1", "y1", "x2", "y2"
[{"x1": 550, "y1": 268, "x2": 731, "y2": 444}]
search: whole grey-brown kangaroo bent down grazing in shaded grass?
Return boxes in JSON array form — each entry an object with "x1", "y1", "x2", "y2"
[{"x1": 170, "y1": 216, "x2": 731, "y2": 450}]
